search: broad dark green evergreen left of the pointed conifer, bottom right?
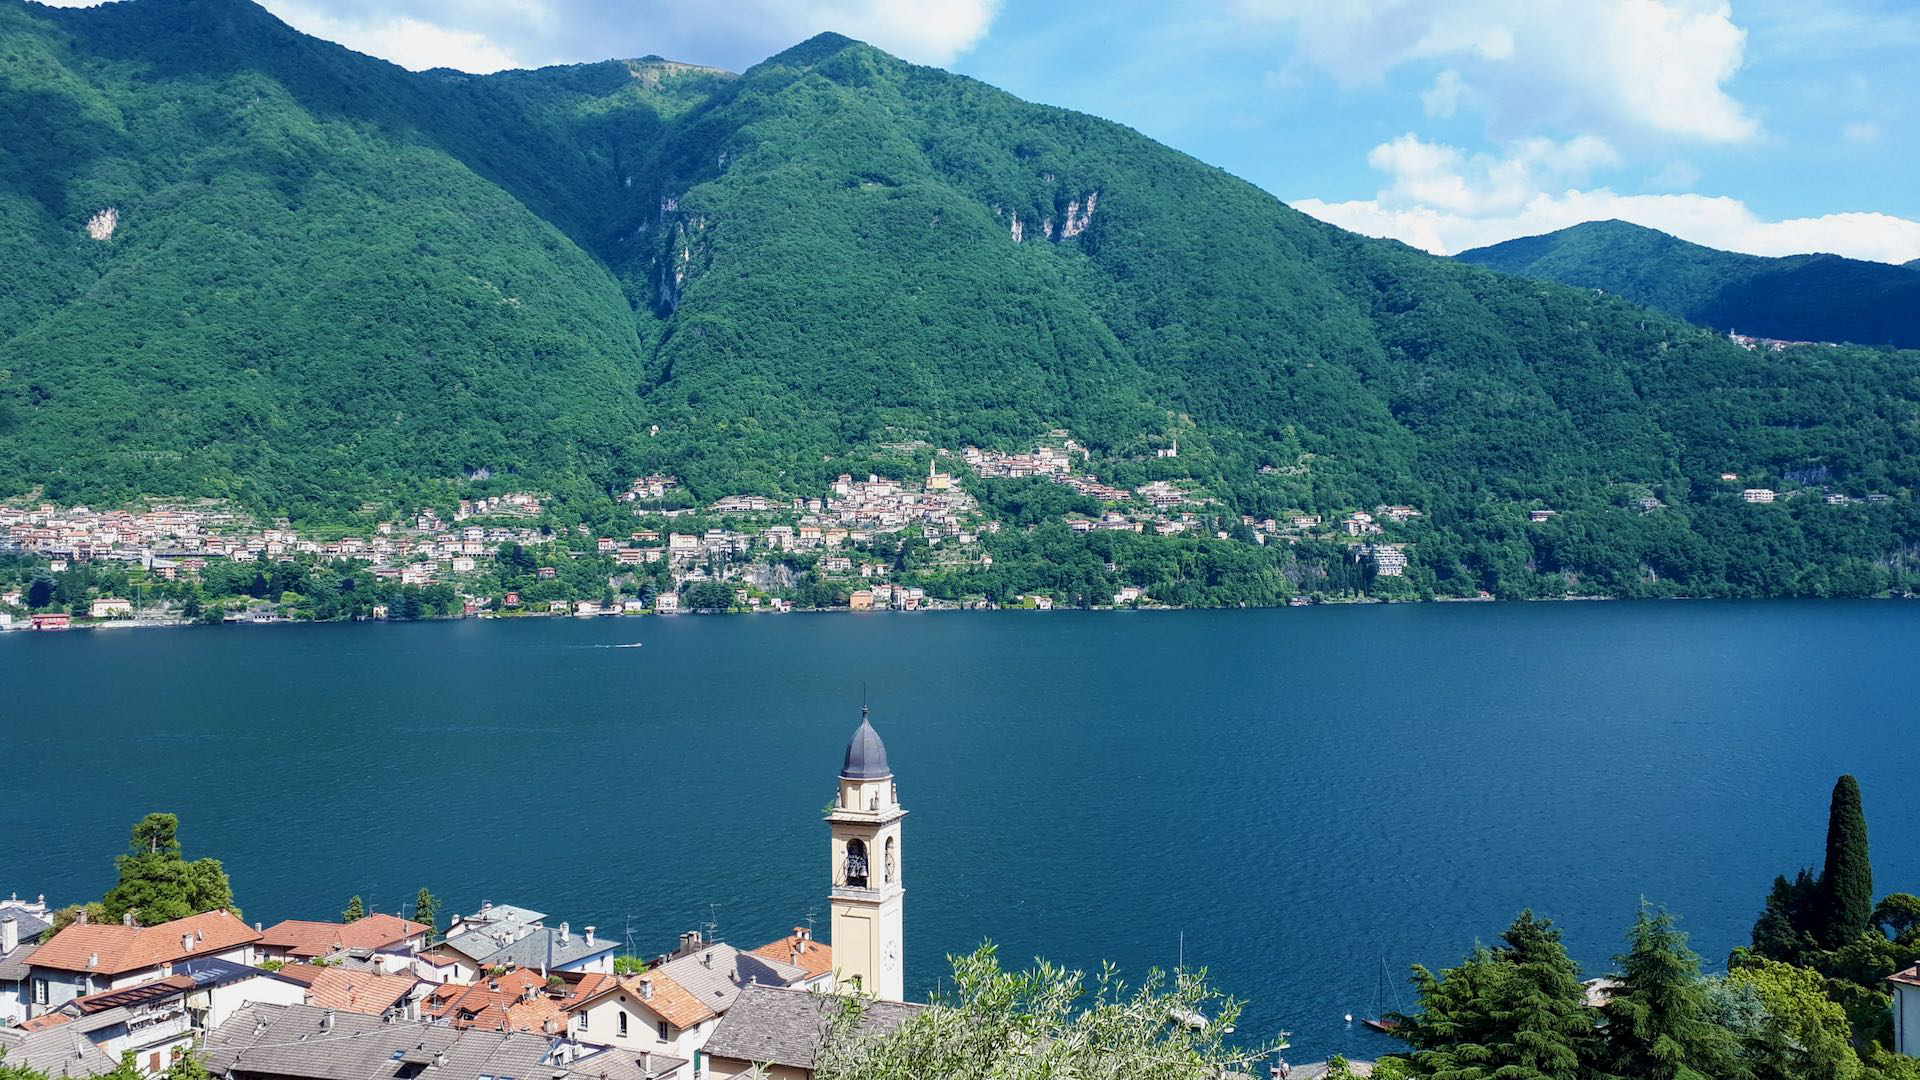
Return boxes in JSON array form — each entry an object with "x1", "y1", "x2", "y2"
[{"x1": 1394, "y1": 911, "x2": 1594, "y2": 1080}]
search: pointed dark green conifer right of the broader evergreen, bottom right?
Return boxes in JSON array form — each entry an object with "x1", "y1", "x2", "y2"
[{"x1": 1601, "y1": 907, "x2": 1747, "y2": 1080}]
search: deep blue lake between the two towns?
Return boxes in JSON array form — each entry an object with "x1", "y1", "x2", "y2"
[{"x1": 0, "y1": 601, "x2": 1920, "y2": 1061}]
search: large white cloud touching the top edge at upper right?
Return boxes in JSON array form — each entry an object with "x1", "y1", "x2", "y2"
[{"x1": 1240, "y1": 0, "x2": 1761, "y2": 142}]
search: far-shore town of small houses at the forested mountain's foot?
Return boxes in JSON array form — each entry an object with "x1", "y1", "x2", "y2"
[{"x1": 0, "y1": 430, "x2": 1889, "y2": 630}]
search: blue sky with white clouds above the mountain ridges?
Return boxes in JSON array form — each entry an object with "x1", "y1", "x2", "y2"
[{"x1": 52, "y1": 0, "x2": 1920, "y2": 261}]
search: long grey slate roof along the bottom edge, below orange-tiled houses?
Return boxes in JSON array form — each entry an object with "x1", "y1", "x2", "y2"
[{"x1": 204, "y1": 1005, "x2": 555, "y2": 1080}]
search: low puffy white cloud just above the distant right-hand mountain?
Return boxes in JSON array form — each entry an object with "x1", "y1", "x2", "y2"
[{"x1": 1294, "y1": 135, "x2": 1920, "y2": 263}]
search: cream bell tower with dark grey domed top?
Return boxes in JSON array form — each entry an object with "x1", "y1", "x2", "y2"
[{"x1": 828, "y1": 707, "x2": 906, "y2": 1001}]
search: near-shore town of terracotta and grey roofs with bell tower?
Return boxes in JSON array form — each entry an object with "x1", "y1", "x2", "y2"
[{"x1": 0, "y1": 709, "x2": 1327, "y2": 1080}]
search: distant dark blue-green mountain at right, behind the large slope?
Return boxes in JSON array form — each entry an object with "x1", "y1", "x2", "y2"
[{"x1": 1455, "y1": 221, "x2": 1920, "y2": 348}]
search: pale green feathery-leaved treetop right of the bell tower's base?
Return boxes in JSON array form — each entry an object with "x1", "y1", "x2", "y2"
[{"x1": 814, "y1": 945, "x2": 1267, "y2": 1080}]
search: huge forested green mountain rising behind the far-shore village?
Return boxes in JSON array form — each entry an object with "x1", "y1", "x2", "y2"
[{"x1": 0, "y1": 0, "x2": 1920, "y2": 594}]
